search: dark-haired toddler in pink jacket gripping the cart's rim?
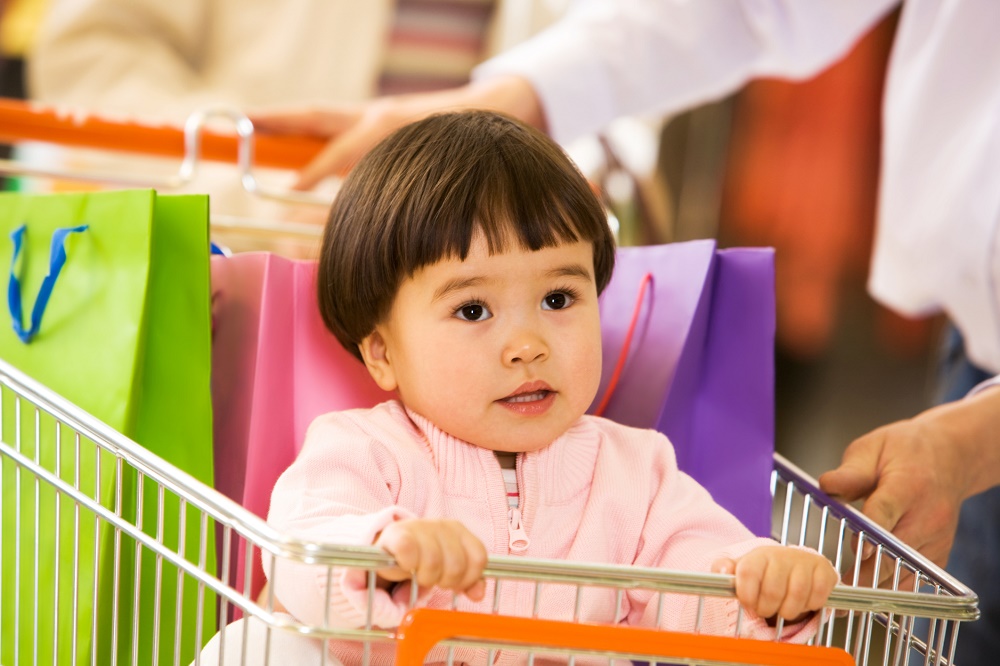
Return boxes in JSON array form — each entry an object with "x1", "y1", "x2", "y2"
[{"x1": 195, "y1": 111, "x2": 838, "y2": 661}]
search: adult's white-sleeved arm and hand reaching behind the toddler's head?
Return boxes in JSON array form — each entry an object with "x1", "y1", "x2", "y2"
[{"x1": 251, "y1": 0, "x2": 899, "y2": 189}]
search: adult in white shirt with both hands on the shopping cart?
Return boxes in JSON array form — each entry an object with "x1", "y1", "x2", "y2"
[{"x1": 254, "y1": 0, "x2": 1000, "y2": 665}]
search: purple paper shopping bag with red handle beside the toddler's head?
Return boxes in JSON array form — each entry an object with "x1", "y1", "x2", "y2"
[{"x1": 594, "y1": 240, "x2": 775, "y2": 535}]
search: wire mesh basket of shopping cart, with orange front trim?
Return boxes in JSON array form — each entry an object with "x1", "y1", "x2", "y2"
[{"x1": 0, "y1": 363, "x2": 978, "y2": 666}]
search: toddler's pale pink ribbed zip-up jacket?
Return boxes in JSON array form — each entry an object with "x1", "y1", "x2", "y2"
[{"x1": 264, "y1": 401, "x2": 816, "y2": 661}]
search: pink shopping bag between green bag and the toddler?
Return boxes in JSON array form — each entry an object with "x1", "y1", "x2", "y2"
[{"x1": 212, "y1": 252, "x2": 390, "y2": 595}]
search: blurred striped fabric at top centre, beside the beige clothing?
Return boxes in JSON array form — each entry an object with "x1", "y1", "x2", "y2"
[{"x1": 378, "y1": 0, "x2": 496, "y2": 95}]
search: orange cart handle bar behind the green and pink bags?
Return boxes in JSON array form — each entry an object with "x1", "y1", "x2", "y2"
[{"x1": 0, "y1": 99, "x2": 323, "y2": 169}]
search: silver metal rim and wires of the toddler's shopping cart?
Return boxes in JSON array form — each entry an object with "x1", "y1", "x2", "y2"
[{"x1": 0, "y1": 350, "x2": 979, "y2": 664}]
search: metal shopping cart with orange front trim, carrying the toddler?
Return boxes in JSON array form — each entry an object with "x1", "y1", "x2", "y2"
[{"x1": 0, "y1": 362, "x2": 979, "y2": 666}]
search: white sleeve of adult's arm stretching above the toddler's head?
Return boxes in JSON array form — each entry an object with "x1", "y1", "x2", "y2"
[{"x1": 474, "y1": 0, "x2": 898, "y2": 142}]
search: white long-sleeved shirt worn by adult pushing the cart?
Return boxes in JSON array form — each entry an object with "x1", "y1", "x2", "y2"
[{"x1": 475, "y1": 0, "x2": 1000, "y2": 372}]
